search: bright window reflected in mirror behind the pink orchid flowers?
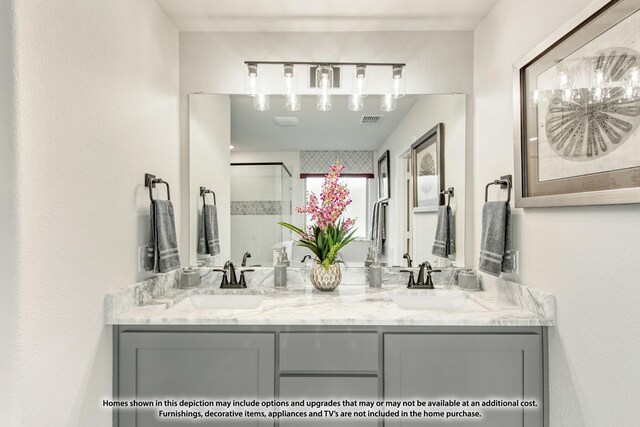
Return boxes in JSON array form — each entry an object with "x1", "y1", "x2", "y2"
[{"x1": 305, "y1": 177, "x2": 368, "y2": 238}]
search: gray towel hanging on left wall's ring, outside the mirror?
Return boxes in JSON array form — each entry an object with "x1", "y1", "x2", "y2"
[{"x1": 145, "y1": 200, "x2": 180, "y2": 273}]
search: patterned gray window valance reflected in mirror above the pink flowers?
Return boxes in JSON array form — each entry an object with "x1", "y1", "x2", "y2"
[{"x1": 300, "y1": 151, "x2": 373, "y2": 178}]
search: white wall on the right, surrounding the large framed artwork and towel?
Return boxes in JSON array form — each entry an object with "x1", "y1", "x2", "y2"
[{"x1": 474, "y1": 0, "x2": 640, "y2": 427}]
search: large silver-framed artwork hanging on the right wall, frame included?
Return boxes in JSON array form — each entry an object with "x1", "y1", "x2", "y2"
[{"x1": 514, "y1": 0, "x2": 640, "y2": 207}]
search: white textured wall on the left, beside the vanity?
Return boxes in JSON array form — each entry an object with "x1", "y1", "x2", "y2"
[{"x1": 7, "y1": 0, "x2": 180, "y2": 427}]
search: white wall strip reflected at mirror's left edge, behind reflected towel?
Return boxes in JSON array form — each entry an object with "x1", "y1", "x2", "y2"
[{"x1": 189, "y1": 94, "x2": 231, "y2": 265}]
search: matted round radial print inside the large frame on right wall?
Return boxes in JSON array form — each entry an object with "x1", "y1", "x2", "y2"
[{"x1": 537, "y1": 9, "x2": 640, "y2": 182}]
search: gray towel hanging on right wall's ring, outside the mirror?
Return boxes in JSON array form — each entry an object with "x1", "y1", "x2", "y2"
[{"x1": 478, "y1": 202, "x2": 514, "y2": 276}]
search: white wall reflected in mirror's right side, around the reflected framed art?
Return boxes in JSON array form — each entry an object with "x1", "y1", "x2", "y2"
[{"x1": 378, "y1": 95, "x2": 473, "y2": 266}]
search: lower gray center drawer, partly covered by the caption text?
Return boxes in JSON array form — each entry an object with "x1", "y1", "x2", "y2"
[{"x1": 280, "y1": 376, "x2": 378, "y2": 427}]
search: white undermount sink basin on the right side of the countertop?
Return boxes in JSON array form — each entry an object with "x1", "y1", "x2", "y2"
[{"x1": 392, "y1": 290, "x2": 486, "y2": 311}]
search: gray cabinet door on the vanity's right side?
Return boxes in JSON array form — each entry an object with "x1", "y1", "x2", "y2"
[{"x1": 384, "y1": 334, "x2": 544, "y2": 427}]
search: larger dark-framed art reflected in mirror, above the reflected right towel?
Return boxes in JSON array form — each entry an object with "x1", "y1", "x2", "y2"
[{"x1": 411, "y1": 123, "x2": 444, "y2": 212}]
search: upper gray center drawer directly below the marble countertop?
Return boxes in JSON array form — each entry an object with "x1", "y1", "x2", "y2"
[{"x1": 280, "y1": 332, "x2": 378, "y2": 372}]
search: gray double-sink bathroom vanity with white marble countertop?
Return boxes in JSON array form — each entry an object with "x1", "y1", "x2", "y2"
[{"x1": 107, "y1": 268, "x2": 554, "y2": 427}]
